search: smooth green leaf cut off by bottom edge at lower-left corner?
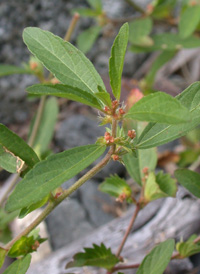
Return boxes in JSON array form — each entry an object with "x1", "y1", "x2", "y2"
[{"x1": 2, "y1": 254, "x2": 31, "y2": 274}]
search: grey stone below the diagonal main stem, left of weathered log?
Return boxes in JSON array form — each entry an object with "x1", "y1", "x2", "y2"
[{"x1": 46, "y1": 198, "x2": 93, "y2": 250}]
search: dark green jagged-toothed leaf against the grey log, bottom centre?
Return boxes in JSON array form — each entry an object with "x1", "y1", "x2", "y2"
[{"x1": 66, "y1": 243, "x2": 119, "y2": 270}]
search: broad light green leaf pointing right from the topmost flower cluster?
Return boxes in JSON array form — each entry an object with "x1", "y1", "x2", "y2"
[{"x1": 125, "y1": 92, "x2": 189, "y2": 124}]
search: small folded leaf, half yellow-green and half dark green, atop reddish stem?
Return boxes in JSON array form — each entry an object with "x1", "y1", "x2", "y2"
[{"x1": 144, "y1": 172, "x2": 177, "y2": 202}]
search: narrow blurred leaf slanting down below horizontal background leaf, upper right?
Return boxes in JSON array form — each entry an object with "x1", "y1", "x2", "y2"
[{"x1": 145, "y1": 51, "x2": 175, "y2": 88}]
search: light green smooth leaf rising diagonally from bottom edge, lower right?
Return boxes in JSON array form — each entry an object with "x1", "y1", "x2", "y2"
[{"x1": 136, "y1": 239, "x2": 174, "y2": 274}]
